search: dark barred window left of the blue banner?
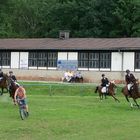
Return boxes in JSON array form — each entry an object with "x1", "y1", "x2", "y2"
[{"x1": 29, "y1": 52, "x2": 57, "y2": 67}]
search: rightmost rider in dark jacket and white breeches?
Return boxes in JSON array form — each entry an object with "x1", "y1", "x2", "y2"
[{"x1": 125, "y1": 69, "x2": 136, "y2": 96}]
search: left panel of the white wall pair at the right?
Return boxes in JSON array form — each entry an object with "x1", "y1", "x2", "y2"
[{"x1": 111, "y1": 52, "x2": 123, "y2": 71}]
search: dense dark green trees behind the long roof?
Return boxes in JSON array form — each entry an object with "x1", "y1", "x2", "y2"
[{"x1": 0, "y1": 0, "x2": 140, "y2": 38}]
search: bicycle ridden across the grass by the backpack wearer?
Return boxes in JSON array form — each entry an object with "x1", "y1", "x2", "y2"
[{"x1": 17, "y1": 99, "x2": 29, "y2": 120}]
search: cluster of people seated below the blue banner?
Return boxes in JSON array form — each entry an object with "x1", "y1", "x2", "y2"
[{"x1": 62, "y1": 71, "x2": 82, "y2": 82}]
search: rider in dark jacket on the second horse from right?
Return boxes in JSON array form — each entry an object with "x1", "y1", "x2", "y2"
[{"x1": 101, "y1": 74, "x2": 109, "y2": 94}]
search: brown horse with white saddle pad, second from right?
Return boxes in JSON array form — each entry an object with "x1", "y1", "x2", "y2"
[{"x1": 95, "y1": 81, "x2": 120, "y2": 102}]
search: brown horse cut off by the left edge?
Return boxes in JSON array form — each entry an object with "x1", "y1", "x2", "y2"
[{"x1": 0, "y1": 73, "x2": 8, "y2": 95}]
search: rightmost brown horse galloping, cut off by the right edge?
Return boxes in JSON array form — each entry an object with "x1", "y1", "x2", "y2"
[{"x1": 122, "y1": 79, "x2": 140, "y2": 108}]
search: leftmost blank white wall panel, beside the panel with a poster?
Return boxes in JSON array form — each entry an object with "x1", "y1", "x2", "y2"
[{"x1": 11, "y1": 52, "x2": 19, "y2": 68}]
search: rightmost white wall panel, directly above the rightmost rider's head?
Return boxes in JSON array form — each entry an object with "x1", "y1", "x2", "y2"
[{"x1": 123, "y1": 52, "x2": 135, "y2": 71}]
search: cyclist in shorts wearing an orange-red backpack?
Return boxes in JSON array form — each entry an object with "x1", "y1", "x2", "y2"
[{"x1": 14, "y1": 84, "x2": 29, "y2": 115}]
